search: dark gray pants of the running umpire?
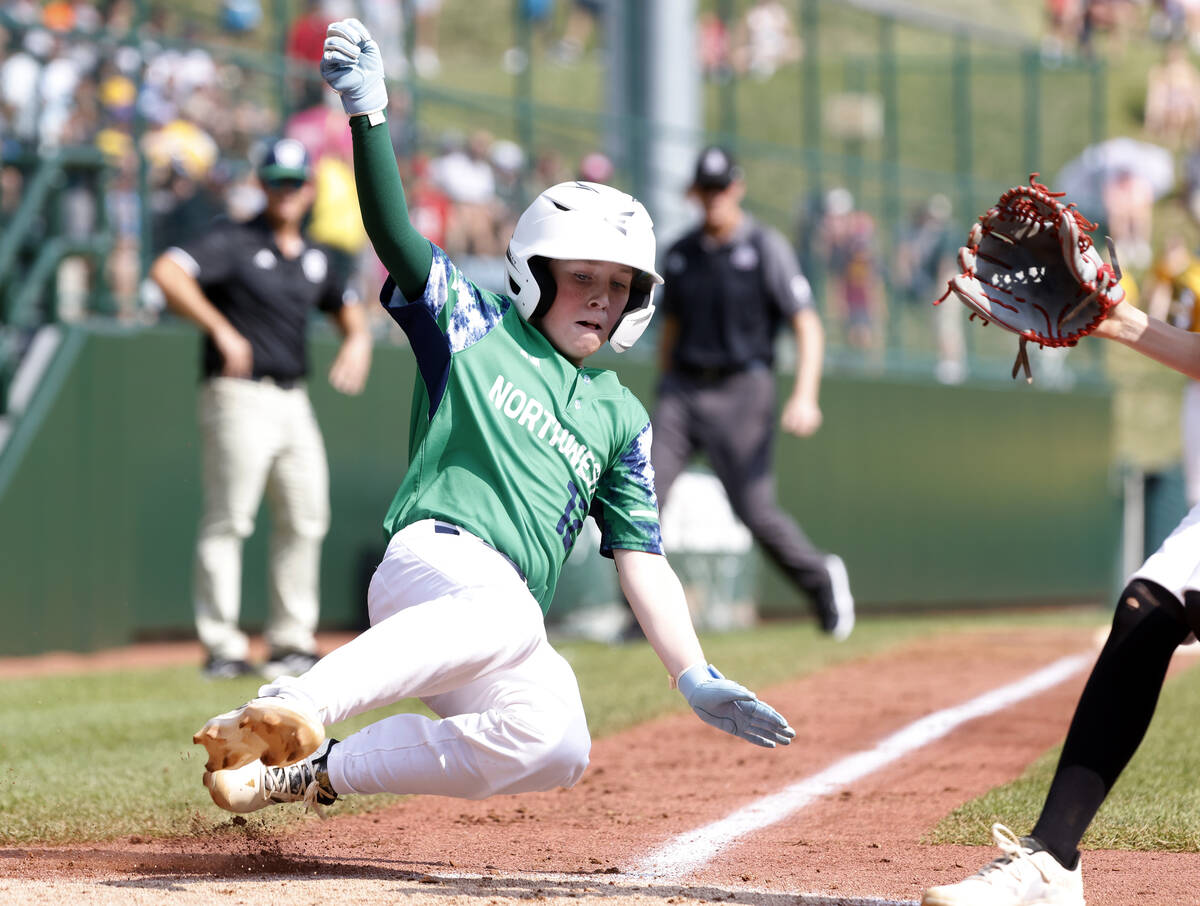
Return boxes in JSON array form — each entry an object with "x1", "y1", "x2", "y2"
[{"x1": 650, "y1": 366, "x2": 833, "y2": 616}]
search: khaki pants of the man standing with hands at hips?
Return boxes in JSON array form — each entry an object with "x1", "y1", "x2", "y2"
[{"x1": 194, "y1": 378, "x2": 329, "y2": 659}]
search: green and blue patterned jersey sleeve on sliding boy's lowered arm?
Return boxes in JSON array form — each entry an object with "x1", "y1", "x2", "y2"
[{"x1": 590, "y1": 421, "x2": 662, "y2": 557}]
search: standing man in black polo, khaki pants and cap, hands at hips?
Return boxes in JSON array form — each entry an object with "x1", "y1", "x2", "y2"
[{"x1": 150, "y1": 139, "x2": 371, "y2": 678}]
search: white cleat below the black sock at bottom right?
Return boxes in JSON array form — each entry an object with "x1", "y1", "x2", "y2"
[{"x1": 920, "y1": 824, "x2": 1084, "y2": 906}]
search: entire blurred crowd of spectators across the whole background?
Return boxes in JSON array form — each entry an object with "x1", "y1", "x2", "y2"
[{"x1": 16, "y1": 0, "x2": 1200, "y2": 383}]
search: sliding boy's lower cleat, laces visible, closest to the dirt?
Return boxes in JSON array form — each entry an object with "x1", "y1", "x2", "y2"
[{"x1": 204, "y1": 739, "x2": 337, "y2": 816}]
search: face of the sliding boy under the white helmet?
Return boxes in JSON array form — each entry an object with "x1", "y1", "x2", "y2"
[{"x1": 538, "y1": 258, "x2": 634, "y2": 365}]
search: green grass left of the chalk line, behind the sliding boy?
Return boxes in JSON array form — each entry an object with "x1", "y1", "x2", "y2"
[{"x1": 0, "y1": 611, "x2": 1097, "y2": 845}]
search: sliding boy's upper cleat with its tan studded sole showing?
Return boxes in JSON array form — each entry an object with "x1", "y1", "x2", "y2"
[{"x1": 192, "y1": 696, "x2": 325, "y2": 770}]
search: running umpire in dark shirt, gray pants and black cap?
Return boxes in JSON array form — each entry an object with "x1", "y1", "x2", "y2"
[{"x1": 652, "y1": 148, "x2": 854, "y2": 640}]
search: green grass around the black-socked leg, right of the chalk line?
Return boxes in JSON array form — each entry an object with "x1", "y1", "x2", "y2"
[{"x1": 928, "y1": 648, "x2": 1200, "y2": 852}]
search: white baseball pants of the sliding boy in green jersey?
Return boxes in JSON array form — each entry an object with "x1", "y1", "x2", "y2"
[{"x1": 259, "y1": 520, "x2": 592, "y2": 799}]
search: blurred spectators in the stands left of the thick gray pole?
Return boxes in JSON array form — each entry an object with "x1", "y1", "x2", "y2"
[{"x1": 0, "y1": 0, "x2": 613, "y2": 330}]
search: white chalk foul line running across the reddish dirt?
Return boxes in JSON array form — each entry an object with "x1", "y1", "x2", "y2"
[{"x1": 626, "y1": 654, "x2": 1094, "y2": 880}]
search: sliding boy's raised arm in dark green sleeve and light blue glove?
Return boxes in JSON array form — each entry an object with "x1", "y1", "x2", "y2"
[{"x1": 320, "y1": 19, "x2": 433, "y2": 299}]
